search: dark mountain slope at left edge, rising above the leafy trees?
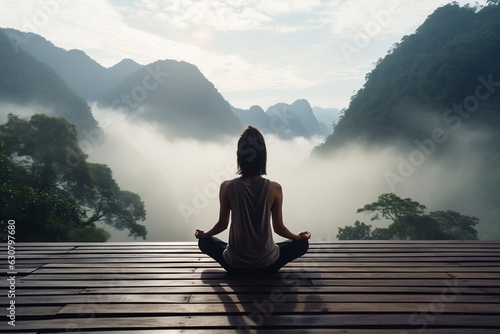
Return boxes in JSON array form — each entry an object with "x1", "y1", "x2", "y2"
[{"x1": 0, "y1": 30, "x2": 97, "y2": 135}]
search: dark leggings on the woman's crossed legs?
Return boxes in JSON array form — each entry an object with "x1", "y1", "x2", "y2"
[{"x1": 198, "y1": 237, "x2": 309, "y2": 275}]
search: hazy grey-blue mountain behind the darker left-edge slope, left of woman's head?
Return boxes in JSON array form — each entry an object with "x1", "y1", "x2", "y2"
[{"x1": 3, "y1": 29, "x2": 241, "y2": 139}]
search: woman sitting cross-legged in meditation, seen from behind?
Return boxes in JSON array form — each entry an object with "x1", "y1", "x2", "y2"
[{"x1": 195, "y1": 126, "x2": 311, "y2": 275}]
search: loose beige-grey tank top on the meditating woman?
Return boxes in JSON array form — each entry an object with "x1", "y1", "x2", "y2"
[{"x1": 223, "y1": 178, "x2": 279, "y2": 268}]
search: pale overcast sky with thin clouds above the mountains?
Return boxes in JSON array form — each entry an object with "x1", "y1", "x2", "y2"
[{"x1": 0, "y1": 0, "x2": 485, "y2": 109}]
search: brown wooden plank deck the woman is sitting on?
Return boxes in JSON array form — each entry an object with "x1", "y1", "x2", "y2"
[{"x1": 0, "y1": 241, "x2": 500, "y2": 334}]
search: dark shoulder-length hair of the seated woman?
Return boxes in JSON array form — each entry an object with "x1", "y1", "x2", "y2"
[{"x1": 236, "y1": 126, "x2": 267, "y2": 176}]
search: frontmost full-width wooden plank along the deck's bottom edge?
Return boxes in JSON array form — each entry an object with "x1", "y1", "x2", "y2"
[{"x1": 5, "y1": 313, "x2": 500, "y2": 331}]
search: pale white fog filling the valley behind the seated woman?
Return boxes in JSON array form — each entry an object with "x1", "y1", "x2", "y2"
[{"x1": 86, "y1": 105, "x2": 488, "y2": 241}]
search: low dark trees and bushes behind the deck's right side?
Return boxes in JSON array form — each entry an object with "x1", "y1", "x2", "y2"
[{"x1": 337, "y1": 193, "x2": 479, "y2": 240}]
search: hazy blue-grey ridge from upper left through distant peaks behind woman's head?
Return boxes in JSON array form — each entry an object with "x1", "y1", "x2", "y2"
[{"x1": 3, "y1": 29, "x2": 335, "y2": 140}]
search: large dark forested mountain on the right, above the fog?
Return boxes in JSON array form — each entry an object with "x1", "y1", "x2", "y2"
[{"x1": 315, "y1": 3, "x2": 500, "y2": 154}]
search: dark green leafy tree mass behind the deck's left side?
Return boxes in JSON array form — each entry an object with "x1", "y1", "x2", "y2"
[{"x1": 0, "y1": 114, "x2": 147, "y2": 241}]
